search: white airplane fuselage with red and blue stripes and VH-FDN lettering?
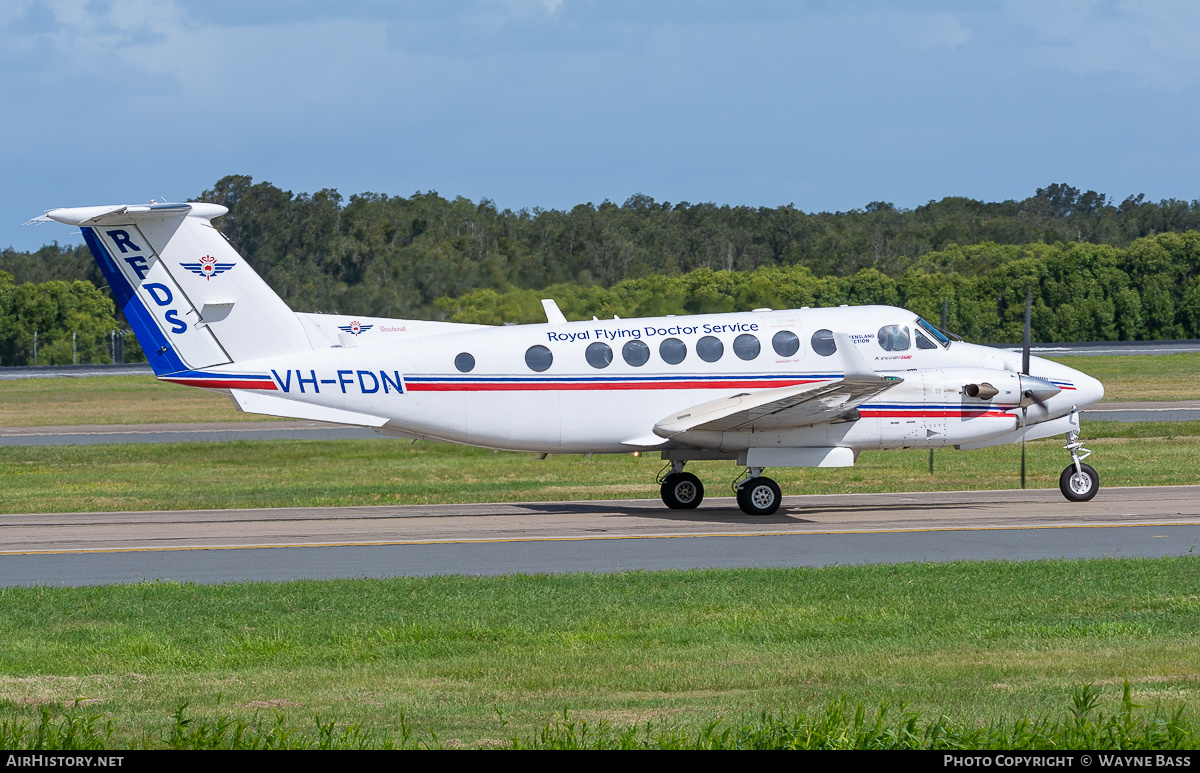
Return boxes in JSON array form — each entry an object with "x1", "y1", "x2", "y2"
[{"x1": 189, "y1": 306, "x2": 1103, "y2": 454}]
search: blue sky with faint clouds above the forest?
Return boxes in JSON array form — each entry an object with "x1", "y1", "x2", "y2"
[{"x1": 0, "y1": 0, "x2": 1200, "y2": 250}]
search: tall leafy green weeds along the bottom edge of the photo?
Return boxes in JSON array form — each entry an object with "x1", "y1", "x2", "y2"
[{"x1": 9, "y1": 679, "x2": 1200, "y2": 744}]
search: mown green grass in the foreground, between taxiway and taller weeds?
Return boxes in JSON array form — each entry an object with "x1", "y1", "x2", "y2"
[{"x1": 0, "y1": 557, "x2": 1200, "y2": 745}]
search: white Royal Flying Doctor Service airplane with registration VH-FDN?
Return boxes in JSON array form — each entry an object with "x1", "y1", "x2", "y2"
[{"x1": 38, "y1": 203, "x2": 1104, "y2": 515}]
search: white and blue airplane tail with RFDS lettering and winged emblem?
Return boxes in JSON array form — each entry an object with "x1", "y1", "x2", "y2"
[{"x1": 47, "y1": 203, "x2": 311, "y2": 376}]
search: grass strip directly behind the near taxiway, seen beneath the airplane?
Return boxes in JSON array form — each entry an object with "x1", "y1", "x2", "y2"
[{"x1": 0, "y1": 421, "x2": 1200, "y2": 513}]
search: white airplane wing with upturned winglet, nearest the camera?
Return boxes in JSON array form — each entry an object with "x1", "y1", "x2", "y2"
[{"x1": 654, "y1": 334, "x2": 904, "y2": 438}]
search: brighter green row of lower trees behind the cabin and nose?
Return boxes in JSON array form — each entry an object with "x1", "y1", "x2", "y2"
[{"x1": 438, "y1": 232, "x2": 1200, "y2": 342}]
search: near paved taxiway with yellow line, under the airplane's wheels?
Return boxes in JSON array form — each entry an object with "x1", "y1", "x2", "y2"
[{"x1": 0, "y1": 486, "x2": 1200, "y2": 586}]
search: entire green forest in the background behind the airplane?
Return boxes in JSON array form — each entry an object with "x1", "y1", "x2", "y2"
[{"x1": 0, "y1": 175, "x2": 1200, "y2": 365}]
